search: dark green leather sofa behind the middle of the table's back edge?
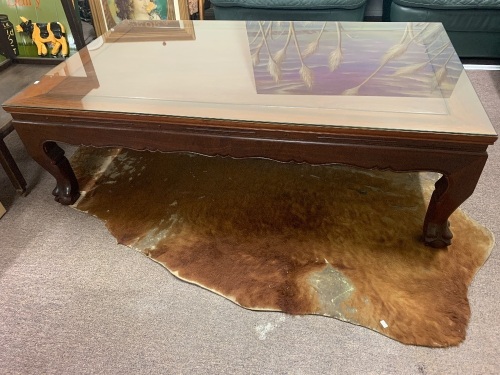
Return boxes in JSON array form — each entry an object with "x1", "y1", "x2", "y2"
[{"x1": 211, "y1": 0, "x2": 367, "y2": 21}]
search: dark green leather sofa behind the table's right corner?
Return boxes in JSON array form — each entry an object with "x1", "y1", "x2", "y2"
[{"x1": 383, "y1": 0, "x2": 500, "y2": 58}]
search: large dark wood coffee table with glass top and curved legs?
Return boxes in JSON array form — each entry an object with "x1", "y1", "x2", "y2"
[{"x1": 4, "y1": 21, "x2": 497, "y2": 247}]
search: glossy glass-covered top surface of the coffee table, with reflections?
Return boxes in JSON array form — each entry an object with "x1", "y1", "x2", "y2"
[{"x1": 3, "y1": 21, "x2": 495, "y2": 135}]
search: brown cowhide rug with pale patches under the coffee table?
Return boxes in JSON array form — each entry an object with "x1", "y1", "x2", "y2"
[{"x1": 72, "y1": 148, "x2": 494, "y2": 347}]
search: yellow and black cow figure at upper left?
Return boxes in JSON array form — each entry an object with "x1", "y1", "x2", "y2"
[{"x1": 16, "y1": 17, "x2": 69, "y2": 57}]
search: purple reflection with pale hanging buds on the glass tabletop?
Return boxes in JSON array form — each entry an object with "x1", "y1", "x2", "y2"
[{"x1": 247, "y1": 21, "x2": 463, "y2": 98}]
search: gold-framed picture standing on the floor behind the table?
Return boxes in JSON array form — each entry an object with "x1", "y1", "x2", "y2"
[{"x1": 89, "y1": 0, "x2": 190, "y2": 36}]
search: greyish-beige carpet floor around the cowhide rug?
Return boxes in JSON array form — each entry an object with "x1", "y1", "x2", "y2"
[{"x1": 0, "y1": 66, "x2": 500, "y2": 374}]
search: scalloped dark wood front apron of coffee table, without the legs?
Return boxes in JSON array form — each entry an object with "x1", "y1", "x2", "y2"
[{"x1": 6, "y1": 113, "x2": 488, "y2": 173}]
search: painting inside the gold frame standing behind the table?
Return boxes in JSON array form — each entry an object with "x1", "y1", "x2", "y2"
[{"x1": 107, "y1": 0, "x2": 167, "y2": 23}]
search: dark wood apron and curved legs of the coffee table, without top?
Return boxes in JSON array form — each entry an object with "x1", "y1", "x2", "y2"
[{"x1": 5, "y1": 99, "x2": 497, "y2": 247}]
